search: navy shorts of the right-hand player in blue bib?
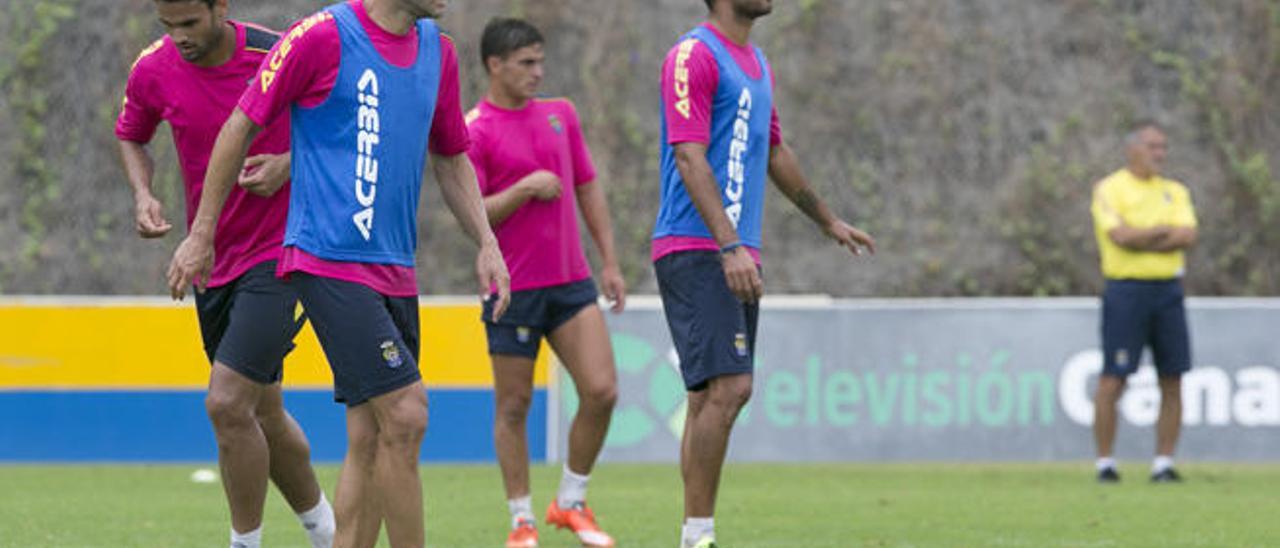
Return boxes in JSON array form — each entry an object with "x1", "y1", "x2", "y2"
[{"x1": 654, "y1": 251, "x2": 760, "y2": 392}]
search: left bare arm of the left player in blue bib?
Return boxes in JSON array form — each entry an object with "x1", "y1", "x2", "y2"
[{"x1": 168, "y1": 108, "x2": 262, "y2": 300}]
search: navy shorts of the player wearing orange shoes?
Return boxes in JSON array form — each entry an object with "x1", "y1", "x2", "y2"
[{"x1": 481, "y1": 278, "x2": 599, "y2": 360}]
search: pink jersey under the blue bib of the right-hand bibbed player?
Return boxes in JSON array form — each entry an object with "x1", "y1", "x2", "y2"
[{"x1": 650, "y1": 23, "x2": 782, "y2": 262}]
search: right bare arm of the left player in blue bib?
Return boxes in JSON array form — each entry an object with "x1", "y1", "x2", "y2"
[{"x1": 431, "y1": 152, "x2": 511, "y2": 321}]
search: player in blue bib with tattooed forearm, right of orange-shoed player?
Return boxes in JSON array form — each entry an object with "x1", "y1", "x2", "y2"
[{"x1": 653, "y1": 0, "x2": 876, "y2": 548}]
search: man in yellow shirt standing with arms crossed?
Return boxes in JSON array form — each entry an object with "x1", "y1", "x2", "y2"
[{"x1": 1092, "y1": 122, "x2": 1197, "y2": 483}]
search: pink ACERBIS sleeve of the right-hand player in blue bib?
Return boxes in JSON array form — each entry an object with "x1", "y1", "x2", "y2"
[{"x1": 662, "y1": 38, "x2": 719, "y2": 145}]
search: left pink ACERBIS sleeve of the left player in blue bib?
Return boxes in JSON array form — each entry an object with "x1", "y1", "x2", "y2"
[{"x1": 239, "y1": 12, "x2": 342, "y2": 127}]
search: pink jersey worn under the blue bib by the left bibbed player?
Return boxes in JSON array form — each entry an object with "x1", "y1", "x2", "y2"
[{"x1": 239, "y1": 0, "x2": 470, "y2": 297}]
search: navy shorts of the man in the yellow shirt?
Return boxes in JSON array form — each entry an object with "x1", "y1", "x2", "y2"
[{"x1": 1102, "y1": 280, "x2": 1192, "y2": 376}]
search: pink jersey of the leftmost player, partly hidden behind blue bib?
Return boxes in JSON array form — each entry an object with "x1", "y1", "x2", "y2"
[{"x1": 115, "y1": 20, "x2": 289, "y2": 287}]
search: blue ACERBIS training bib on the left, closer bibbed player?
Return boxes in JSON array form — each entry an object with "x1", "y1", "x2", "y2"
[{"x1": 284, "y1": 3, "x2": 440, "y2": 266}]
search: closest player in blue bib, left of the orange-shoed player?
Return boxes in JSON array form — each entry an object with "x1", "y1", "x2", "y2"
[{"x1": 170, "y1": 0, "x2": 511, "y2": 547}]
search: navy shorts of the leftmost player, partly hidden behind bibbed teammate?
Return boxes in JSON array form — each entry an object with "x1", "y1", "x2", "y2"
[{"x1": 196, "y1": 261, "x2": 306, "y2": 384}]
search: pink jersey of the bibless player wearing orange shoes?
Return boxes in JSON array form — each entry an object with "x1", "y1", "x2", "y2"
[{"x1": 467, "y1": 99, "x2": 595, "y2": 291}]
